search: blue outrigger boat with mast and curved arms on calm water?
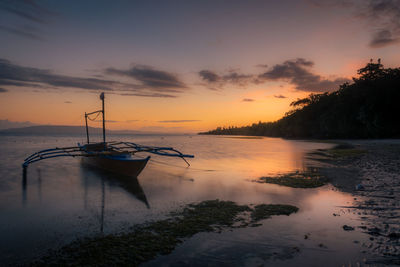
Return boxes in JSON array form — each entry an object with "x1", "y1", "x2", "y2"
[{"x1": 22, "y1": 93, "x2": 194, "y2": 177}]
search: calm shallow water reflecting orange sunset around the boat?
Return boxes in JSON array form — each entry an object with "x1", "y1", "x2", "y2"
[{"x1": 0, "y1": 136, "x2": 366, "y2": 266}]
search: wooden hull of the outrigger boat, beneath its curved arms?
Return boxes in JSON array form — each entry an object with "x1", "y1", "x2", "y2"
[{"x1": 82, "y1": 156, "x2": 150, "y2": 177}]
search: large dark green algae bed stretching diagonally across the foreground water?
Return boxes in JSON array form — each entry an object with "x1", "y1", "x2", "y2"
[{"x1": 32, "y1": 200, "x2": 298, "y2": 266}]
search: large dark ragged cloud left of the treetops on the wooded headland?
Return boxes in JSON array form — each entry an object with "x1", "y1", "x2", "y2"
[{"x1": 258, "y1": 58, "x2": 350, "y2": 92}]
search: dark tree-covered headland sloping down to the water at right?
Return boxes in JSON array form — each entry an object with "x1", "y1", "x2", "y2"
[{"x1": 200, "y1": 60, "x2": 400, "y2": 139}]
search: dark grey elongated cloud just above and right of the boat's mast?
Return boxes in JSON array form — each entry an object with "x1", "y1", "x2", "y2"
[{"x1": 105, "y1": 65, "x2": 187, "y2": 92}]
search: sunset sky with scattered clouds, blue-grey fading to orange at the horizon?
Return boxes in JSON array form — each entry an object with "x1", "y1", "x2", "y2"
[{"x1": 0, "y1": 0, "x2": 400, "y2": 132}]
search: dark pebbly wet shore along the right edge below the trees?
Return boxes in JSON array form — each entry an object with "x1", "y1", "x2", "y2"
[{"x1": 311, "y1": 140, "x2": 400, "y2": 265}]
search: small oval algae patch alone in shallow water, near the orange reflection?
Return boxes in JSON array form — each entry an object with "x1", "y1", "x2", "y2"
[{"x1": 256, "y1": 171, "x2": 327, "y2": 188}]
